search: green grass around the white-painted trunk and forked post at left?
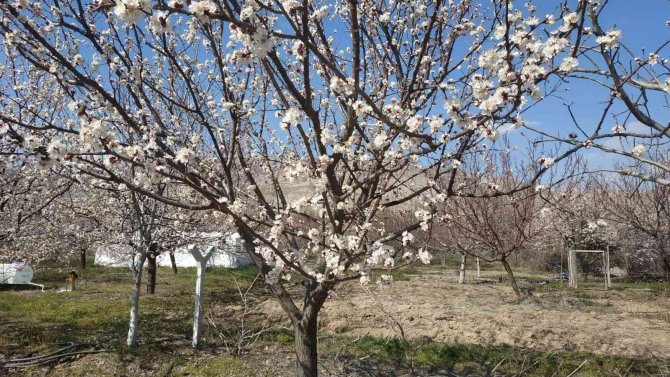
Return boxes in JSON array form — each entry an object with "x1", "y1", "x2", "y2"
[{"x1": 0, "y1": 267, "x2": 265, "y2": 354}]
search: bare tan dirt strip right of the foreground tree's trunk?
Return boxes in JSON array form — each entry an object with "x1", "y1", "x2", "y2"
[{"x1": 266, "y1": 275, "x2": 670, "y2": 359}]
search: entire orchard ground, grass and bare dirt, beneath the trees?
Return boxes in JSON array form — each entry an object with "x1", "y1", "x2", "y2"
[{"x1": 0, "y1": 260, "x2": 670, "y2": 376}]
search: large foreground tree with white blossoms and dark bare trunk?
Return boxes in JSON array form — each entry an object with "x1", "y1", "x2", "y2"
[{"x1": 0, "y1": 0, "x2": 600, "y2": 376}]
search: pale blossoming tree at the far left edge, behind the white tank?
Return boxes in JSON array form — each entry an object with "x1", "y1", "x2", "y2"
[{"x1": 0, "y1": 163, "x2": 105, "y2": 268}]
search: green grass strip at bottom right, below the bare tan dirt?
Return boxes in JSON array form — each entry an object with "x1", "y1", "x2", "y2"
[{"x1": 328, "y1": 337, "x2": 665, "y2": 377}]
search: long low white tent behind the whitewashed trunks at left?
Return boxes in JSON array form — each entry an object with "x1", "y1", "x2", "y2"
[{"x1": 95, "y1": 232, "x2": 251, "y2": 268}]
